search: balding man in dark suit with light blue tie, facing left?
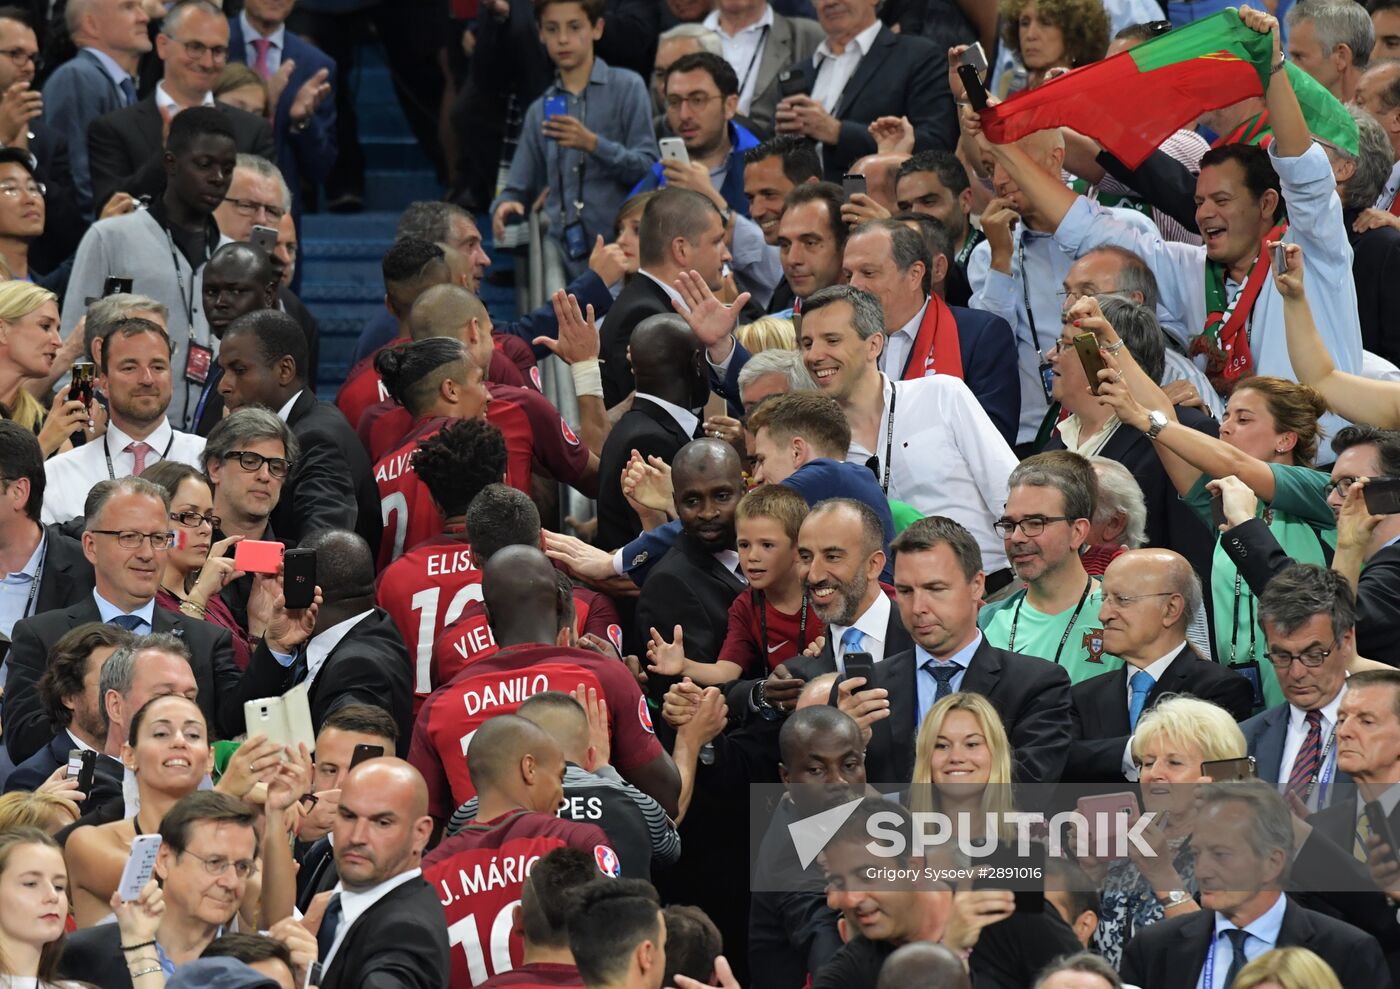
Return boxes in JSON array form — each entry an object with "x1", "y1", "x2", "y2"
[{"x1": 1064, "y1": 549, "x2": 1254, "y2": 783}]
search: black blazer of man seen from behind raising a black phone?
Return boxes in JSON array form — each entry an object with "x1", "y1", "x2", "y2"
[{"x1": 239, "y1": 608, "x2": 413, "y2": 750}]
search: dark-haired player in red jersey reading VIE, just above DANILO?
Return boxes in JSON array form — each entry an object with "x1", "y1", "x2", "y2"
[{"x1": 430, "y1": 485, "x2": 622, "y2": 688}]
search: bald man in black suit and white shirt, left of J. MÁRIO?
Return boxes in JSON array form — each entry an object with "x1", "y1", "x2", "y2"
[{"x1": 316, "y1": 759, "x2": 451, "y2": 989}]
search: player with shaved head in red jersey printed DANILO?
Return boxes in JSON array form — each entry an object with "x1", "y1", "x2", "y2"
[{"x1": 409, "y1": 546, "x2": 680, "y2": 821}]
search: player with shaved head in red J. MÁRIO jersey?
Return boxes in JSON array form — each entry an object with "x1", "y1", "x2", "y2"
[{"x1": 423, "y1": 711, "x2": 622, "y2": 986}]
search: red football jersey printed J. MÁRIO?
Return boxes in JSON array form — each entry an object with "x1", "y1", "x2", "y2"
[{"x1": 423, "y1": 810, "x2": 622, "y2": 989}]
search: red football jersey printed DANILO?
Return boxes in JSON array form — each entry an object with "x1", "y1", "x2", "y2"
[{"x1": 409, "y1": 643, "x2": 662, "y2": 821}]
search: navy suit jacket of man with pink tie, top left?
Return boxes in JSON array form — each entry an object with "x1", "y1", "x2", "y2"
[{"x1": 228, "y1": 15, "x2": 336, "y2": 217}]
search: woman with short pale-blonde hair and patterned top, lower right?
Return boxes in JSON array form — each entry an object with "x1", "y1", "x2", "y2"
[{"x1": 1079, "y1": 695, "x2": 1247, "y2": 968}]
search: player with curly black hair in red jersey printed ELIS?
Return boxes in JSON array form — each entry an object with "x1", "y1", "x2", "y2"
[{"x1": 375, "y1": 419, "x2": 509, "y2": 700}]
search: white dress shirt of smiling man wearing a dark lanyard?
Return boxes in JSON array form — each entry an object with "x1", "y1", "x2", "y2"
[{"x1": 846, "y1": 374, "x2": 1016, "y2": 573}]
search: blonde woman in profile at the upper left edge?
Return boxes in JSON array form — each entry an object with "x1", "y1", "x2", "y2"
[{"x1": 0, "y1": 282, "x2": 88, "y2": 457}]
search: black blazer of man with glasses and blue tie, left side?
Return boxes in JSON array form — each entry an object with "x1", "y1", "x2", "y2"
[{"x1": 0, "y1": 594, "x2": 240, "y2": 763}]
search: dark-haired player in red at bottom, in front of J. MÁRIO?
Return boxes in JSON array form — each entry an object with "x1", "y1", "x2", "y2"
[{"x1": 482, "y1": 848, "x2": 599, "y2": 989}]
